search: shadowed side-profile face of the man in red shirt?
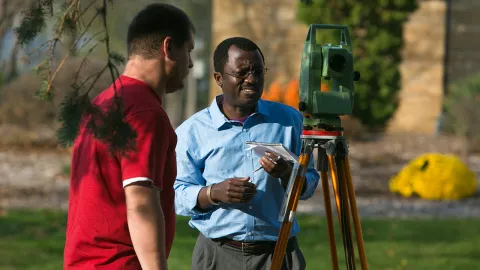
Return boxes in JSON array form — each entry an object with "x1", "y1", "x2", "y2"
[{"x1": 166, "y1": 33, "x2": 195, "y2": 93}]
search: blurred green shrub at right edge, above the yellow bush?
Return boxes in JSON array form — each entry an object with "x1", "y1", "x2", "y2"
[{"x1": 444, "y1": 73, "x2": 480, "y2": 151}]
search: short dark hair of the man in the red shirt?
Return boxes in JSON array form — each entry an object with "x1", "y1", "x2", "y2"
[{"x1": 127, "y1": 3, "x2": 195, "y2": 59}]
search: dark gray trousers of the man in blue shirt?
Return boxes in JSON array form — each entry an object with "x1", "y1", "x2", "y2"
[{"x1": 192, "y1": 234, "x2": 306, "y2": 270}]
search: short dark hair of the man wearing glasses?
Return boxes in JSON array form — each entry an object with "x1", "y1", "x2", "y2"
[{"x1": 213, "y1": 37, "x2": 265, "y2": 74}]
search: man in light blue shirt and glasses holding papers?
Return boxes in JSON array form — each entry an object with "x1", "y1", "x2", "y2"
[{"x1": 174, "y1": 37, "x2": 319, "y2": 270}]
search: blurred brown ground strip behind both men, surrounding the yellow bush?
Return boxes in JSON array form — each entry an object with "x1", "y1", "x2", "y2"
[{"x1": 0, "y1": 136, "x2": 480, "y2": 217}]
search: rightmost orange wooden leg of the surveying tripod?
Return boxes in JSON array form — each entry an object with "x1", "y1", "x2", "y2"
[{"x1": 342, "y1": 156, "x2": 368, "y2": 270}]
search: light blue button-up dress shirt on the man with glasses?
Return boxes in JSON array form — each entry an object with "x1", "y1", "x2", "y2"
[{"x1": 174, "y1": 96, "x2": 319, "y2": 241}]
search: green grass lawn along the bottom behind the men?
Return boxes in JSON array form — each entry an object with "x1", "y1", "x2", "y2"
[{"x1": 0, "y1": 211, "x2": 480, "y2": 270}]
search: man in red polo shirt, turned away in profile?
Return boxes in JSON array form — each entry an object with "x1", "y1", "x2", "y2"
[{"x1": 64, "y1": 4, "x2": 195, "y2": 270}]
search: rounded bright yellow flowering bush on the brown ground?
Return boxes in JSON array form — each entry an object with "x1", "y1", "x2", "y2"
[{"x1": 389, "y1": 153, "x2": 477, "y2": 200}]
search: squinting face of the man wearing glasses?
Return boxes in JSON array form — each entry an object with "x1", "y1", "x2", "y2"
[{"x1": 215, "y1": 45, "x2": 265, "y2": 107}]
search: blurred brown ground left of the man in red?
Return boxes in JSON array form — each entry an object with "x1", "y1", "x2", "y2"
[{"x1": 0, "y1": 148, "x2": 70, "y2": 208}]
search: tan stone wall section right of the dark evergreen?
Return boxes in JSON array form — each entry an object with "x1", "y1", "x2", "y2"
[{"x1": 387, "y1": 0, "x2": 446, "y2": 134}]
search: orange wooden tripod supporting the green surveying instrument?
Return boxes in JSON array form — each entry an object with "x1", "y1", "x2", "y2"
[{"x1": 270, "y1": 132, "x2": 368, "y2": 270}]
